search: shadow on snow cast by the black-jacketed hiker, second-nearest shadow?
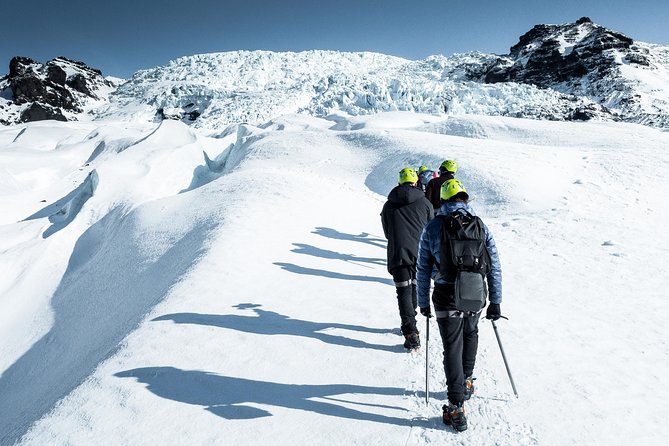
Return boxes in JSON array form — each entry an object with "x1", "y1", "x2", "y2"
[{"x1": 153, "y1": 304, "x2": 404, "y2": 352}]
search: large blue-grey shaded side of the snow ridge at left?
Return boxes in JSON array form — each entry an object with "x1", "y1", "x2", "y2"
[{"x1": 0, "y1": 207, "x2": 213, "y2": 445}]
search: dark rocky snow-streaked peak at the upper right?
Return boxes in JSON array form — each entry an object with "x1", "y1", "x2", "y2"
[{"x1": 470, "y1": 17, "x2": 669, "y2": 127}]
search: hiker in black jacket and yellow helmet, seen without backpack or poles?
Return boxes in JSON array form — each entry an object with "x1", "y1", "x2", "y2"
[{"x1": 381, "y1": 167, "x2": 434, "y2": 350}]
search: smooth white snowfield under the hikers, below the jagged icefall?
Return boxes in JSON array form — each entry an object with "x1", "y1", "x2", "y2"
[{"x1": 0, "y1": 110, "x2": 669, "y2": 445}]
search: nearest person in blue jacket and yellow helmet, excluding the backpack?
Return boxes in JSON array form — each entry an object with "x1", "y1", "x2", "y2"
[{"x1": 416, "y1": 179, "x2": 502, "y2": 431}]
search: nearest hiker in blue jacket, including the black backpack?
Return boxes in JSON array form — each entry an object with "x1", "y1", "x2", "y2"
[{"x1": 417, "y1": 179, "x2": 502, "y2": 431}]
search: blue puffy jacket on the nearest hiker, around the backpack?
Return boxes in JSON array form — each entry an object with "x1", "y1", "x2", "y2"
[{"x1": 416, "y1": 201, "x2": 502, "y2": 308}]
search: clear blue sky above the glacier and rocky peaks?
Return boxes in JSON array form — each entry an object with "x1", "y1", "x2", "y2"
[{"x1": 0, "y1": 0, "x2": 669, "y2": 77}]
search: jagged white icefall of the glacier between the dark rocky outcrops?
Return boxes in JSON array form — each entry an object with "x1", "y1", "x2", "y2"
[{"x1": 102, "y1": 51, "x2": 620, "y2": 131}]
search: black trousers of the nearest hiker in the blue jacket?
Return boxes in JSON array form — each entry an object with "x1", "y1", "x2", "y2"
[{"x1": 432, "y1": 286, "x2": 481, "y2": 404}]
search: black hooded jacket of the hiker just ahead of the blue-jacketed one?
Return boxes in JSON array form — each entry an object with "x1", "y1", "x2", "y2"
[{"x1": 381, "y1": 183, "x2": 434, "y2": 271}]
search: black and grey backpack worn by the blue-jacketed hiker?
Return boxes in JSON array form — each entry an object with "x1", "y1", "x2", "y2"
[{"x1": 439, "y1": 210, "x2": 490, "y2": 312}]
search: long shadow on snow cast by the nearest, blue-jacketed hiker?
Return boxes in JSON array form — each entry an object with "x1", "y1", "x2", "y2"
[{"x1": 114, "y1": 367, "x2": 411, "y2": 426}]
